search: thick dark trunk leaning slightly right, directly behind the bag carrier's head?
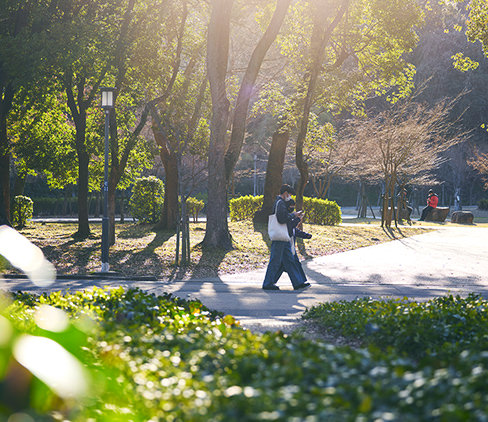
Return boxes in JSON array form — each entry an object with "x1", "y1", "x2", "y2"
[{"x1": 253, "y1": 129, "x2": 290, "y2": 223}]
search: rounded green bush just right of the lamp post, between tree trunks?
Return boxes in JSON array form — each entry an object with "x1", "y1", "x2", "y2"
[{"x1": 129, "y1": 176, "x2": 164, "y2": 223}]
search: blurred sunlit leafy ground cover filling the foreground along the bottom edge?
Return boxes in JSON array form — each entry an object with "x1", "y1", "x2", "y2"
[{"x1": 0, "y1": 288, "x2": 488, "y2": 421}]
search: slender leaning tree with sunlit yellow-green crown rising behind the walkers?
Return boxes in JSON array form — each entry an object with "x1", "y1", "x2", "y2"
[{"x1": 250, "y1": 0, "x2": 422, "y2": 218}]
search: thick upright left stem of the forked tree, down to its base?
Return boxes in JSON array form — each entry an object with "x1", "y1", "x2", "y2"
[{"x1": 203, "y1": 0, "x2": 233, "y2": 250}]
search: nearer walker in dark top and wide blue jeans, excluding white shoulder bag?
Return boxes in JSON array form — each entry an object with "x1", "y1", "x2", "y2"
[{"x1": 263, "y1": 184, "x2": 310, "y2": 290}]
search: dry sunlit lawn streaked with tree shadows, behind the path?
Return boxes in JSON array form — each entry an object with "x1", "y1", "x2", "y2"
[{"x1": 11, "y1": 220, "x2": 429, "y2": 279}]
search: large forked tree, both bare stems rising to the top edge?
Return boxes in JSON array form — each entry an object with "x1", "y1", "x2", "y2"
[{"x1": 203, "y1": 0, "x2": 290, "y2": 249}]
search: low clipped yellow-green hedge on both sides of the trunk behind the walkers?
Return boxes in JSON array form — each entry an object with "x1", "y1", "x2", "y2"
[{"x1": 229, "y1": 195, "x2": 342, "y2": 226}]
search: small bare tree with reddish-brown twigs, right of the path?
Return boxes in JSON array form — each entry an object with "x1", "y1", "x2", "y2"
[{"x1": 341, "y1": 98, "x2": 467, "y2": 227}]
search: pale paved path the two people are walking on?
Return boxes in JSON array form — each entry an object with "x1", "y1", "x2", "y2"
[{"x1": 0, "y1": 227, "x2": 488, "y2": 330}]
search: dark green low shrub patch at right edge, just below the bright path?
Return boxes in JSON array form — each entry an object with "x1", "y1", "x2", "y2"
[{"x1": 304, "y1": 294, "x2": 488, "y2": 363}]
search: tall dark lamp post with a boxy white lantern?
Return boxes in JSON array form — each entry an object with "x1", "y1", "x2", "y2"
[{"x1": 100, "y1": 87, "x2": 115, "y2": 273}]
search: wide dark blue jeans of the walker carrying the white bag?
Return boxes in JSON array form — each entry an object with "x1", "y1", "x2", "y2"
[{"x1": 263, "y1": 241, "x2": 306, "y2": 287}]
